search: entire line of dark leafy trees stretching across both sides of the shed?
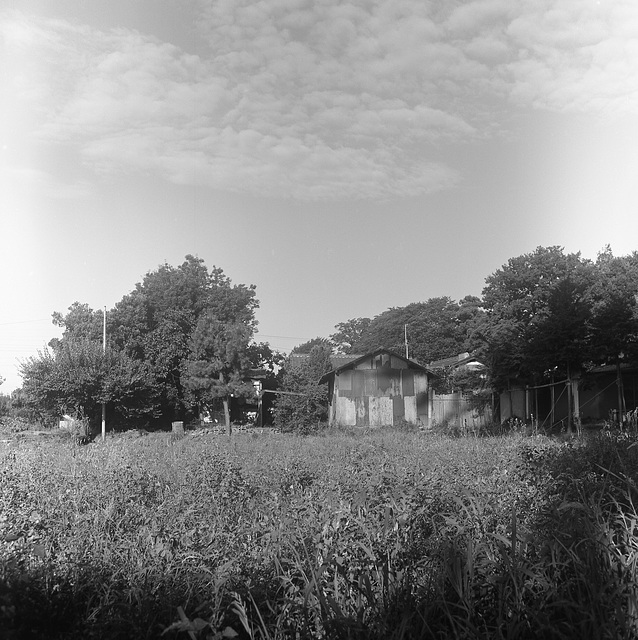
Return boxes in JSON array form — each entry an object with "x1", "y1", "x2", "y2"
[{"x1": 6, "y1": 246, "x2": 638, "y2": 428}]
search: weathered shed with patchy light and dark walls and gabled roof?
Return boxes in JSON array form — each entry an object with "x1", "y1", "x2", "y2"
[{"x1": 320, "y1": 348, "x2": 433, "y2": 427}]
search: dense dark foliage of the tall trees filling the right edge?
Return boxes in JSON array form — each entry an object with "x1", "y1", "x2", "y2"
[{"x1": 473, "y1": 246, "x2": 638, "y2": 388}]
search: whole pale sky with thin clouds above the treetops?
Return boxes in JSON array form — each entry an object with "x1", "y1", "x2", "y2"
[{"x1": 0, "y1": 0, "x2": 638, "y2": 393}]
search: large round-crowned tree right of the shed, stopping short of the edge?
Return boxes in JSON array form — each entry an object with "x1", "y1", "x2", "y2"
[{"x1": 474, "y1": 246, "x2": 595, "y2": 388}]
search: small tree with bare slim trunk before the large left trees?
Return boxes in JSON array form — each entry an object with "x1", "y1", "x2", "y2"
[{"x1": 184, "y1": 312, "x2": 255, "y2": 435}]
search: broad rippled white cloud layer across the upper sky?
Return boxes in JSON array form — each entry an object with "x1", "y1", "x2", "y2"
[{"x1": 0, "y1": 0, "x2": 638, "y2": 198}]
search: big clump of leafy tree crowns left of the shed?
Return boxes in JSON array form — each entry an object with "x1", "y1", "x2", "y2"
[{"x1": 22, "y1": 255, "x2": 273, "y2": 424}]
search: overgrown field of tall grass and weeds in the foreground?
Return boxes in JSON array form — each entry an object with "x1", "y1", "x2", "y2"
[{"x1": 0, "y1": 424, "x2": 638, "y2": 640}]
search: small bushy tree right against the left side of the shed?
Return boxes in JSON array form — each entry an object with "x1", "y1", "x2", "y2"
[{"x1": 274, "y1": 344, "x2": 331, "y2": 434}]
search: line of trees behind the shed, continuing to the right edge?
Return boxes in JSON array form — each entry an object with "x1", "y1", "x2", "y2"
[{"x1": 282, "y1": 246, "x2": 638, "y2": 428}]
